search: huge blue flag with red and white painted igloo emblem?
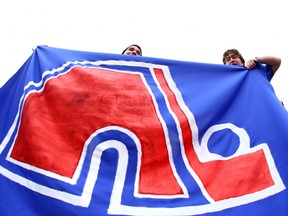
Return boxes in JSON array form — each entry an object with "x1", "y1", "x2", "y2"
[{"x1": 0, "y1": 46, "x2": 288, "y2": 216}]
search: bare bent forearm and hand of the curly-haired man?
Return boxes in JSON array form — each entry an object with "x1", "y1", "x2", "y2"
[{"x1": 246, "y1": 56, "x2": 281, "y2": 73}]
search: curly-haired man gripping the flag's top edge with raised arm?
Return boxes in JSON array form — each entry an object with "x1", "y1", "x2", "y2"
[{"x1": 222, "y1": 49, "x2": 281, "y2": 82}]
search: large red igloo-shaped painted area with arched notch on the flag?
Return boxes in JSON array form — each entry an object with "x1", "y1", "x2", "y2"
[{"x1": 11, "y1": 67, "x2": 182, "y2": 195}]
